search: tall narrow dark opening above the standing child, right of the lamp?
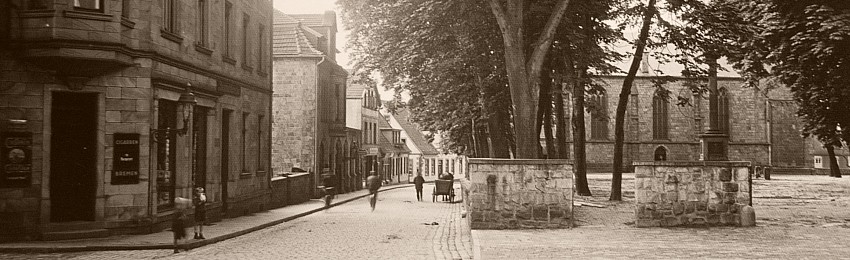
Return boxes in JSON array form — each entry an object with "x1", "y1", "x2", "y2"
[{"x1": 192, "y1": 106, "x2": 209, "y2": 192}]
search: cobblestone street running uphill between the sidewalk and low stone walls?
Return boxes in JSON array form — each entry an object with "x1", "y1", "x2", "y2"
[{"x1": 0, "y1": 185, "x2": 464, "y2": 259}]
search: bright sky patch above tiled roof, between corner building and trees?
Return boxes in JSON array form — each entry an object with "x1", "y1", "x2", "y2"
[{"x1": 274, "y1": 0, "x2": 352, "y2": 68}]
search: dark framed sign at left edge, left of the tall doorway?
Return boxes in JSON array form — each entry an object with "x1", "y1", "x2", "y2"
[{"x1": 0, "y1": 132, "x2": 32, "y2": 188}]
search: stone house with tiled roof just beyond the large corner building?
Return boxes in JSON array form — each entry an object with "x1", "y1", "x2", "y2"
[{"x1": 272, "y1": 11, "x2": 356, "y2": 197}]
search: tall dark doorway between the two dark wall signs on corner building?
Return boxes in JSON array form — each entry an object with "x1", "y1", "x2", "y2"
[{"x1": 50, "y1": 92, "x2": 98, "y2": 222}]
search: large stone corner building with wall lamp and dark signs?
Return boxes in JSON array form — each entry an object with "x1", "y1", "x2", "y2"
[{"x1": 0, "y1": 0, "x2": 272, "y2": 240}]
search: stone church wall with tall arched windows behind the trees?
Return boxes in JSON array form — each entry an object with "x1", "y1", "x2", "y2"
[{"x1": 565, "y1": 76, "x2": 802, "y2": 172}]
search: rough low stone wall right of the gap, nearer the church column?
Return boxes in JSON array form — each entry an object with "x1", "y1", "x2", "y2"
[{"x1": 634, "y1": 161, "x2": 750, "y2": 227}]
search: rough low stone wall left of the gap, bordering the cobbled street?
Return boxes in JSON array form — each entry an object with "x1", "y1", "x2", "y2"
[{"x1": 462, "y1": 159, "x2": 573, "y2": 229}]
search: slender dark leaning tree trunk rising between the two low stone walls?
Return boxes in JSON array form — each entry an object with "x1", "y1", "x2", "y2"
[{"x1": 608, "y1": 0, "x2": 655, "y2": 200}]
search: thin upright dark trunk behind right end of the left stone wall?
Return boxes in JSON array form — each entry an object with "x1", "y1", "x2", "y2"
[{"x1": 568, "y1": 66, "x2": 591, "y2": 196}]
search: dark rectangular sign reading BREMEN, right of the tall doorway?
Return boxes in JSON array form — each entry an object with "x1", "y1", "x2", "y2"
[{"x1": 111, "y1": 133, "x2": 139, "y2": 185}]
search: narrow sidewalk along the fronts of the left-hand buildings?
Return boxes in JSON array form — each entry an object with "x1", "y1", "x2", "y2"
[{"x1": 0, "y1": 184, "x2": 413, "y2": 253}]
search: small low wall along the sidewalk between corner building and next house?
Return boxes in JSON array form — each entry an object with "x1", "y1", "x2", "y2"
[{"x1": 269, "y1": 173, "x2": 313, "y2": 208}]
